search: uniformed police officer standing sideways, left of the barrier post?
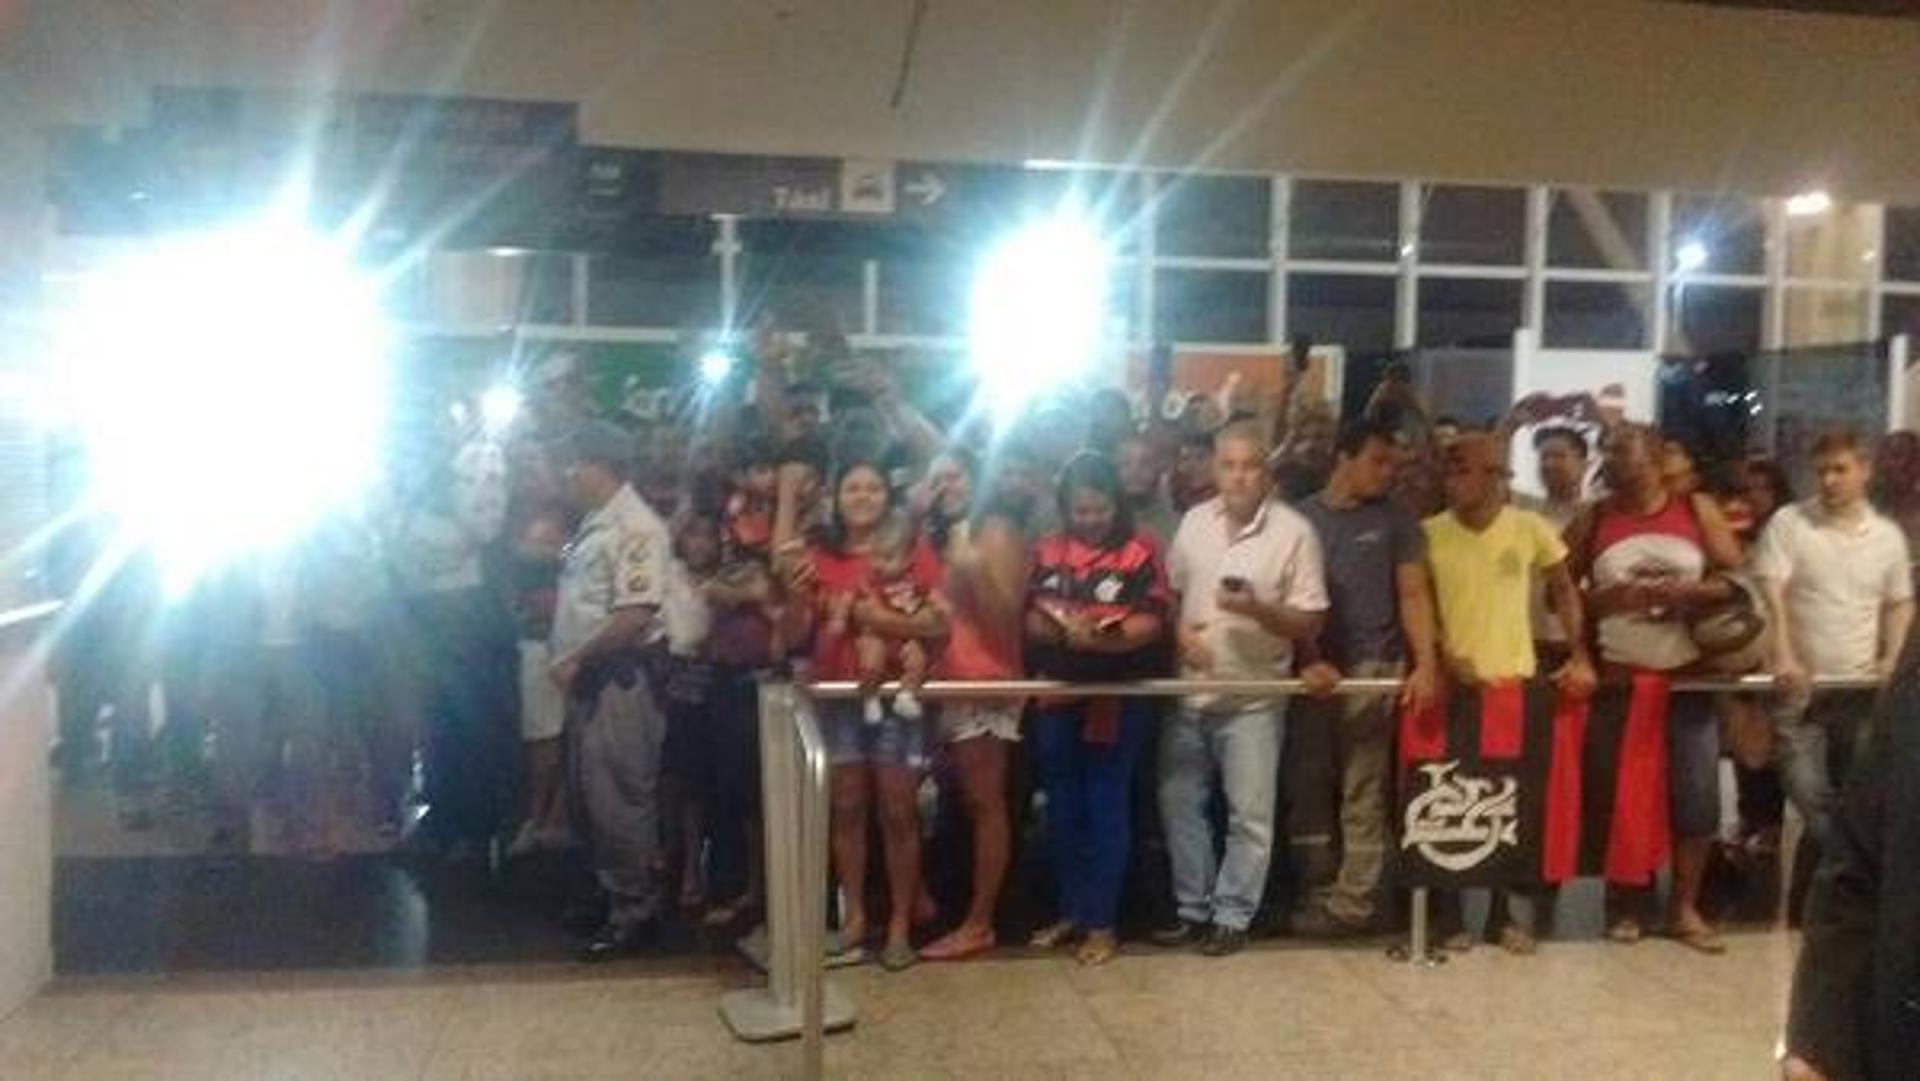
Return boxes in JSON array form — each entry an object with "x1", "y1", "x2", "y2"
[{"x1": 549, "y1": 420, "x2": 670, "y2": 960}]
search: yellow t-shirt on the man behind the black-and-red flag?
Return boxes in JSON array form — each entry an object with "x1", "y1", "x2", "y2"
[{"x1": 1425, "y1": 507, "x2": 1567, "y2": 682}]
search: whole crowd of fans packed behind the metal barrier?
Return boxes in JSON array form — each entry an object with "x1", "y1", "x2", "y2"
[{"x1": 52, "y1": 332, "x2": 1920, "y2": 970}]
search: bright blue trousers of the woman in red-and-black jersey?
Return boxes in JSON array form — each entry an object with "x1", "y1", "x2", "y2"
[{"x1": 1033, "y1": 699, "x2": 1154, "y2": 931}]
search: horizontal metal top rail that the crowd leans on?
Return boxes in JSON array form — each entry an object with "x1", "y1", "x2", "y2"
[{"x1": 804, "y1": 676, "x2": 1884, "y2": 701}]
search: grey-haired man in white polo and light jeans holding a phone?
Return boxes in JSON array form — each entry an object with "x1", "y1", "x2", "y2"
[{"x1": 1154, "y1": 424, "x2": 1327, "y2": 956}]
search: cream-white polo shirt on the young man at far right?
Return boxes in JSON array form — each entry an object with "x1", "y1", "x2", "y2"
[{"x1": 1753, "y1": 499, "x2": 1914, "y2": 676}]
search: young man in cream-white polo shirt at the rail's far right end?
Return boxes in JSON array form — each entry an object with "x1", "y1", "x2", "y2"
[{"x1": 1753, "y1": 432, "x2": 1912, "y2": 845}]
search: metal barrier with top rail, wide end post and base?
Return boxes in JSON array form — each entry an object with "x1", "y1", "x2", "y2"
[{"x1": 720, "y1": 676, "x2": 1882, "y2": 1079}]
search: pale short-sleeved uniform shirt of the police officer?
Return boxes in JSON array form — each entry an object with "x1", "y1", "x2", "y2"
[{"x1": 549, "y1": 484, "x2": 672, "y2": 657}]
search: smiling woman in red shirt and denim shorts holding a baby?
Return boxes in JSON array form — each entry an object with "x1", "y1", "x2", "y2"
[{"x1": 774, "y1": 461, "x2": 947, "y2": 970}]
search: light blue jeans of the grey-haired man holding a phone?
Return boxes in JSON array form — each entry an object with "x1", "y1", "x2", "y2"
[{"x1": 1160, "y1": 703, "x2": 1286, "y2": 931}]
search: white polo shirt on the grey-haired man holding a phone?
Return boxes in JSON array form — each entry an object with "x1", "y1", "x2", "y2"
[{"x1": 1167, "y1": 497, "x2": 1327, "y2": 709}]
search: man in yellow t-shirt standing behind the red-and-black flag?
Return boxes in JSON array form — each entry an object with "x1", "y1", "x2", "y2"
[{"x1": 1425, "y1": 434, "x2": 1594, "y2": 954}]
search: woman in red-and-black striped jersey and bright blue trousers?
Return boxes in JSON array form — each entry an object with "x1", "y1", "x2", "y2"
[{"x1": 1027, "y1": 451, "x2": 1169, "y2": 964}]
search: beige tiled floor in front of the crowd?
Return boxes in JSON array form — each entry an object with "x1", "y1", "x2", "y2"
[{"x1": 0, "y1": 933, "x2": 1793, "y2": 1081}]
